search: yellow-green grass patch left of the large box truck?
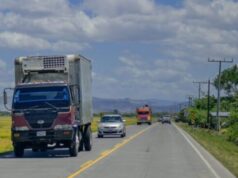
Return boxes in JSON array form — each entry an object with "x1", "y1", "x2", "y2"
[{"x1": 0, "y1": 116, "x2": 12, "y2": 153}]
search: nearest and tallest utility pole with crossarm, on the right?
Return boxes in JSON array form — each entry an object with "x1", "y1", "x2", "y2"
[{"x1": 208, "y1": 58, "x2": 233, "y2": 132}]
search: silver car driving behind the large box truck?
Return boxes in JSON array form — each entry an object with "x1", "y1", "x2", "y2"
[{"x1": 98, "y1": 114, "x2": 126, "y2": 138}]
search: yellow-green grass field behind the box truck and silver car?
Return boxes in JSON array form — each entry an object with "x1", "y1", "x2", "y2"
[{"x1": 0, "y1": 116, "x2": 136, "y2": 153}]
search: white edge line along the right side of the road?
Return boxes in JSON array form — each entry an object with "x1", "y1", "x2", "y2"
[{"x1": 173, "y1": 124, "x2": 220, "y2": 178}]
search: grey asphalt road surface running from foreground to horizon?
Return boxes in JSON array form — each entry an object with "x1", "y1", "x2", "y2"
[{"x1": 0, "y1": 123, "x2": 234, "y2": 178}]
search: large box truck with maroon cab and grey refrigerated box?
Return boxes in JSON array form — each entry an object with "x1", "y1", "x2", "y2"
[{"x1": 4, "y1": 55, "x2": 92, "y2": 157}]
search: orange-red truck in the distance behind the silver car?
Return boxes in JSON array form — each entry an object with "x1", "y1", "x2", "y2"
[{"x1": 136, "y1": 105, "x2": 152, "y2": 125}]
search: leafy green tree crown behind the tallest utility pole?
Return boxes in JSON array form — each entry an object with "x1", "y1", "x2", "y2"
[{"x1": 214, "y1": 65, "x2": 238, "y2": 96}]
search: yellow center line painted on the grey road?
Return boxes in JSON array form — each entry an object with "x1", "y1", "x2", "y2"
[{"x1": 67, "y1": 124, "x2": 157, "y2": 178}]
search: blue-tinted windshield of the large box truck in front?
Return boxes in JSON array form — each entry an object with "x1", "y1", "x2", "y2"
[{"x1": 13, "y1": 86, "x2": 70, "y2": 109}]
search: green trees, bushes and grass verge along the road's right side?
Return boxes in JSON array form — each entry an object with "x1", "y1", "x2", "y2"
[{"x1": 176, "y1": 65, "x2": 238, "y2": 177}]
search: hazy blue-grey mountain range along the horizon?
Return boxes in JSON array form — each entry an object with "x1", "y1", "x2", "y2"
[{"x1": 0, "y1": 96, "x2": 186, "y2": 113}]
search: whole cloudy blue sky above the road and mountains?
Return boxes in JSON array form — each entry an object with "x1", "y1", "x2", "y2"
[{"x1": 0, "y1": 0, "x2": 238, "y2": 101}]
